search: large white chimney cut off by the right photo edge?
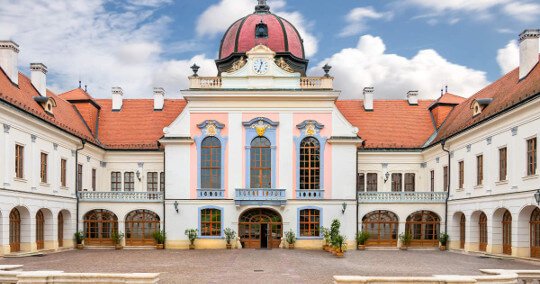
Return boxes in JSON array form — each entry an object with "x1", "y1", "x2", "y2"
[{"x1": 519, "y1": 29, "x2": 540, "y2": 80}]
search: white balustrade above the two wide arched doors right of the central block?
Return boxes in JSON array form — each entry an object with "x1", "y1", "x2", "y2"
[{"x1": 358, "y1": 191, "x2": 446, "y2": 203}]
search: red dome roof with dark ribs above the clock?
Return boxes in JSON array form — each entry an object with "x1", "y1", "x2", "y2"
[{"x1": 219, "y1": 11, "x2": 305, "y2": 59}]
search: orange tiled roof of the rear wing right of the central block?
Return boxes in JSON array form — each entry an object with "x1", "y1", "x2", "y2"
[{"x1": 336, "y1": 100, "x2": 435, "y2": 149}]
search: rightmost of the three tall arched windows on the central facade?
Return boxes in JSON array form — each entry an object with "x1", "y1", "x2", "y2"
[{"x1": 300, "y1": 137, "x2": 321, "y2": 189}]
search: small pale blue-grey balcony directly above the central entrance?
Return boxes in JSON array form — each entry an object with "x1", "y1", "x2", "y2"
[{"x1": 234, "y1": 188, "x2": 287, "y2": 206}]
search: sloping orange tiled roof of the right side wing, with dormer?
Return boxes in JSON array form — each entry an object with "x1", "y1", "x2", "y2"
[{"x1": 433, "y1": 58, "x2": 540, "y2": 143}]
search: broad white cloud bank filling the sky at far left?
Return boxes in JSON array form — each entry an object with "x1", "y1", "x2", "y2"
[{"x1": 0, "y1": 0, "x2": 216, "y2": 98}]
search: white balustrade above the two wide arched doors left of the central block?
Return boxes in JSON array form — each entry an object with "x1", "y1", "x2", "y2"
[{"x1": 78, "y1": 191, "x2": 163, "y2": 202}]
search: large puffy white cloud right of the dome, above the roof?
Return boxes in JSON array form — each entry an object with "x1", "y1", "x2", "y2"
[{"x1": 311, "y1": 35, "x2": 488, "y2": 99}]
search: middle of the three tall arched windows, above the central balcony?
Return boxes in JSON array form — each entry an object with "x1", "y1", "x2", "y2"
[{"x1": 250, "y1": 136, "x2": 272, "y2": 188}]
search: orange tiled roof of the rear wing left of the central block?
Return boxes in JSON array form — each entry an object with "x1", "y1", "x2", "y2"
[{"x1": 96, "y1": 99, "x2": 186, "y2": 150}]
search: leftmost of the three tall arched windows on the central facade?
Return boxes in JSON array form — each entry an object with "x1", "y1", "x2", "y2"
[{"x1": 201, "y1": 136, "x2": 221, "y2": 189}]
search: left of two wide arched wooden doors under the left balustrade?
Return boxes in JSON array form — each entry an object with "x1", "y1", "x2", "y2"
[{"x1": 83, "y1": 209, "x2": 118, "y2": 246}]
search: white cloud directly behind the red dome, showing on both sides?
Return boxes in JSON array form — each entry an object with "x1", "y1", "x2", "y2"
[{"x1": 196, "y1": 0, "x2": 318, "y2": 57}]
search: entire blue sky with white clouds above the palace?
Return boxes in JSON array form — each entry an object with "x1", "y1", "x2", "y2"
[{"x1": 0, "y1": 0, "x2": 540, "y2": 99}]
